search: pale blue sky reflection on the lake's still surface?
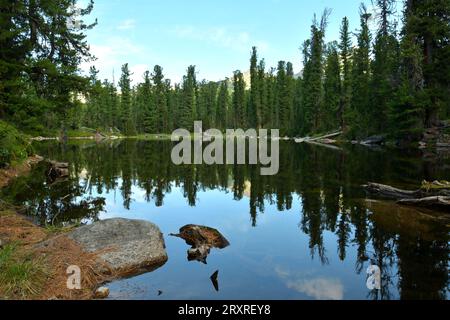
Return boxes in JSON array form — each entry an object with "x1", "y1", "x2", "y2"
[{"x1": 84, "y1": 181, "x2": 392, "y2": 300}]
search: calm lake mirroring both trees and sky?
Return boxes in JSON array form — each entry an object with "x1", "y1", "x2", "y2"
[{"x1": 1, "y1": 140, "x2": 450, "y2": 300}]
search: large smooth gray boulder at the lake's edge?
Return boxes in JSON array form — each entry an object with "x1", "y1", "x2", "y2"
[{"x1": 67, "y1": 219, "x2": 168, "y2": 275}]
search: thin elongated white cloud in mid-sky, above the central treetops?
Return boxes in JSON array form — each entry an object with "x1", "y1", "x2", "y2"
[{"x1": 172, "y1": 26, "x2": 269, "y2": 52}]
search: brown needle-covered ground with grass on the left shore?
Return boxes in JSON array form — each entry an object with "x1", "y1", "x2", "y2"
[{"x1": 0, "y1": 156, "x2": 109, "y2": 300}]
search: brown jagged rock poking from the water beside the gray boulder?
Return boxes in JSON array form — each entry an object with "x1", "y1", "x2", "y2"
[{"x1": 171, "y1": 224, "x2": 230, "y2": 264}]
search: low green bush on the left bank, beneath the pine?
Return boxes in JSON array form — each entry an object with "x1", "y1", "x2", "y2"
[{"x1": 0, "y1": 120, "x2": 33, "y2": 169}]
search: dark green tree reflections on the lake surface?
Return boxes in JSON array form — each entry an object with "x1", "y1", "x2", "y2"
[{"x1": 4, "y1": 141, "x2": 448, "y2": 299}]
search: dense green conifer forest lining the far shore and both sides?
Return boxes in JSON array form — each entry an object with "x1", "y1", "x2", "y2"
[{"x1": 0, "y1": 0, "x2": 450, "y2": 165}]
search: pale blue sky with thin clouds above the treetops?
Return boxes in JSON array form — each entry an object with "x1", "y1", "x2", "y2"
[{"x1": 82, "y1": 0, "x2": 402, "y2": 84}]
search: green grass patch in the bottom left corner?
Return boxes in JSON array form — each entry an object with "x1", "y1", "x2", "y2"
[{"x1": 0, "y1": 243, "x2": 47, "y2": 299}]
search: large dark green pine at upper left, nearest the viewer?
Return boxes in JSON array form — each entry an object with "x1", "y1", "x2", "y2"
[{"x1": 0, "y1": 0, "x2": 96, "y2": 131}]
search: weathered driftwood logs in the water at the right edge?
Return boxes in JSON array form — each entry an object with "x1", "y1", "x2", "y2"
[{"x1": 364, "y1": 181, "x2": 450, "y2": 211}]
